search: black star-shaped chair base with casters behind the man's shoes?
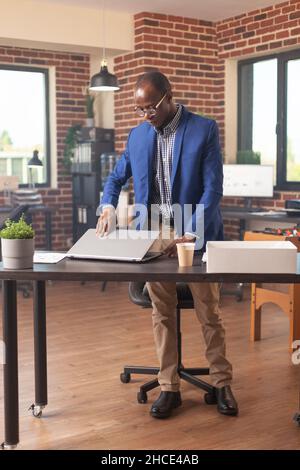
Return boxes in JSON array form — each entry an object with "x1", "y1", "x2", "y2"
[{"x1": 120, "y1": 365, "x2": 217, "y2": 405}]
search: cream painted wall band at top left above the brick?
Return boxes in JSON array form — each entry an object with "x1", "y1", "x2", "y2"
[{"x1": 0, "y1": 0, "x2": 133, "y2": 53}]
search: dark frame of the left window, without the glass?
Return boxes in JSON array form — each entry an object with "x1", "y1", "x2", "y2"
[{"x1": 0, "y1": 63, "x2": 51, "y2": 188}]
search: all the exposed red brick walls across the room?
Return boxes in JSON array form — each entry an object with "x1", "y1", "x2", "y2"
[{"x1": 0, "y1": 0, "x2": 300, "y2": 249}]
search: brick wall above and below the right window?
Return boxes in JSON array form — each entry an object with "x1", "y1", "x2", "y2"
[{"x1": 216, "y1": 0, "x2": 300, "y2": 238}]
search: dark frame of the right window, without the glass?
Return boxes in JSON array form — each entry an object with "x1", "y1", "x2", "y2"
[{"x1": 237, "y1": 49, "x2": 300, "y2": 191}]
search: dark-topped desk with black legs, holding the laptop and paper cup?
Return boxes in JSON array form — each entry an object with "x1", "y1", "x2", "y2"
[{"x1": 0, "y1": 257, "x2": 300, "y2": 447}]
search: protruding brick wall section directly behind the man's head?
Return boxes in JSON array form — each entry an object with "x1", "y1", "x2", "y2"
[{"x1": 114, "y1": 13, "x2": 224, "y2": 151}]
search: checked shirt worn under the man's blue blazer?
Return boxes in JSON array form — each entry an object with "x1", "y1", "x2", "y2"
[{"x1": 151, "y1": 105, "x2": 182, "y2": 219}]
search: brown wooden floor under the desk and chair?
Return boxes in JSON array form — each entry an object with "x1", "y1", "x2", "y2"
[{"x1": 0, "y1": 282, "x2": 300, "y2": 449}]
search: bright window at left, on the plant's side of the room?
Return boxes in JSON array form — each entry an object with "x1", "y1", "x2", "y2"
[{"x1": 0, "y1": 65, "x2": 50, "y2": 186}]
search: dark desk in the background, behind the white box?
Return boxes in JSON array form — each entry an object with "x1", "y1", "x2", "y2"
[{"x1": 221, "y1": 206, "x2": 300, "y2": 240}]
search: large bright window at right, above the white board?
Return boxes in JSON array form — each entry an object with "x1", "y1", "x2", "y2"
[{"x1": 237, "y1": 51, "x2": 300, "y2": 190}]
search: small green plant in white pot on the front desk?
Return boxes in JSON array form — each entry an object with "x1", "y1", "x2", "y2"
[{"x1": 0, "y1": 214, "x2": 35, "y2": 269}]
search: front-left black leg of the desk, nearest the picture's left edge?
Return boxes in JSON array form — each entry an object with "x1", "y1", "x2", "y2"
[{"x1": 2, "y1": 280, "x2": 19, "y2": 449}]
